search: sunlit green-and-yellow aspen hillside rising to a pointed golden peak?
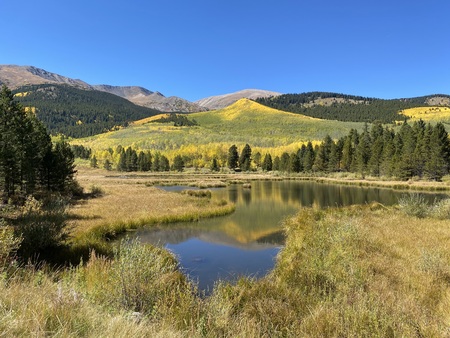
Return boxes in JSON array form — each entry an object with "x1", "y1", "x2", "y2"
[{"x1": 73, "y1": 99, "x2": 363, "y2": 162}]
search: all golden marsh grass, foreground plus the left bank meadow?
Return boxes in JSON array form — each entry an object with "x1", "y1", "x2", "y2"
[{"x1": 0, "y1": 167, "x2": 450, "y2": 337}]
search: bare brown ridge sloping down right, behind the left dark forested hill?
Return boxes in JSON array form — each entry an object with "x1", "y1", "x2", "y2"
[{"x1": 93, "y1": 85, "x2": 208, "y2": 113}]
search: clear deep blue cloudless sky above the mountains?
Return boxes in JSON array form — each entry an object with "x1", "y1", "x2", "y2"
[{"x1": 0, "y1": 0, "x2": 450, "y2": 101}]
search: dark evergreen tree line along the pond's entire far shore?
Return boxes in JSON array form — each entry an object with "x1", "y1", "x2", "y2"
[{"x1": 76, "y1": 120, "x2": 450, "y2": 180}]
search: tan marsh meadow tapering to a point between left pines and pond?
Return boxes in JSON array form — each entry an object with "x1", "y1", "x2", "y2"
[{"x1": 66, "y1": 168, "x2": 235, "y2": 261}]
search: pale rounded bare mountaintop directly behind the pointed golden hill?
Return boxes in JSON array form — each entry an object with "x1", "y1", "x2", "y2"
[{"x1": 194, "y1": 89, "x2": 281, "y2": 109}]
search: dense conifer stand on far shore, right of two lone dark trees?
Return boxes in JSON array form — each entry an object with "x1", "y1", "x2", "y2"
[{"x1": 251, "y1": 120, "x2": 450, "y2": 180}]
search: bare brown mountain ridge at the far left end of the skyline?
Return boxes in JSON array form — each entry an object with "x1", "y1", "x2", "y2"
[{"x1": 0, "y1": 65, "x2": 92, "y2": 89}]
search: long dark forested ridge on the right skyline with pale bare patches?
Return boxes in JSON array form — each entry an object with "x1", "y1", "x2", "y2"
[{"x1": 256, "y1": 92, "x2": 450, "y2": 123}]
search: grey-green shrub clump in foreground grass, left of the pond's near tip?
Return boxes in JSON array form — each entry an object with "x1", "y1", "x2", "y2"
[{"x1": 81, "y1": 239, "x2": 195, "y2": 318}]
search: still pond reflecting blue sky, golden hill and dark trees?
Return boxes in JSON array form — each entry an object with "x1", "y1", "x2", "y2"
[{"x1": 128, "y1": 181, "x2": 442, "y2": 293}]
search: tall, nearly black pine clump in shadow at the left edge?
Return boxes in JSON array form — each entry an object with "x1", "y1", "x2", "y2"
[{"x1": 0, "y1": 85, "x2": 75, "y2": 203}]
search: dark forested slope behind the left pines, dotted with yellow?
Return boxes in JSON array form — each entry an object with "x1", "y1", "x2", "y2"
[{"x1": 13, "y1": 83, "x2": 161, "y2": 137}]
